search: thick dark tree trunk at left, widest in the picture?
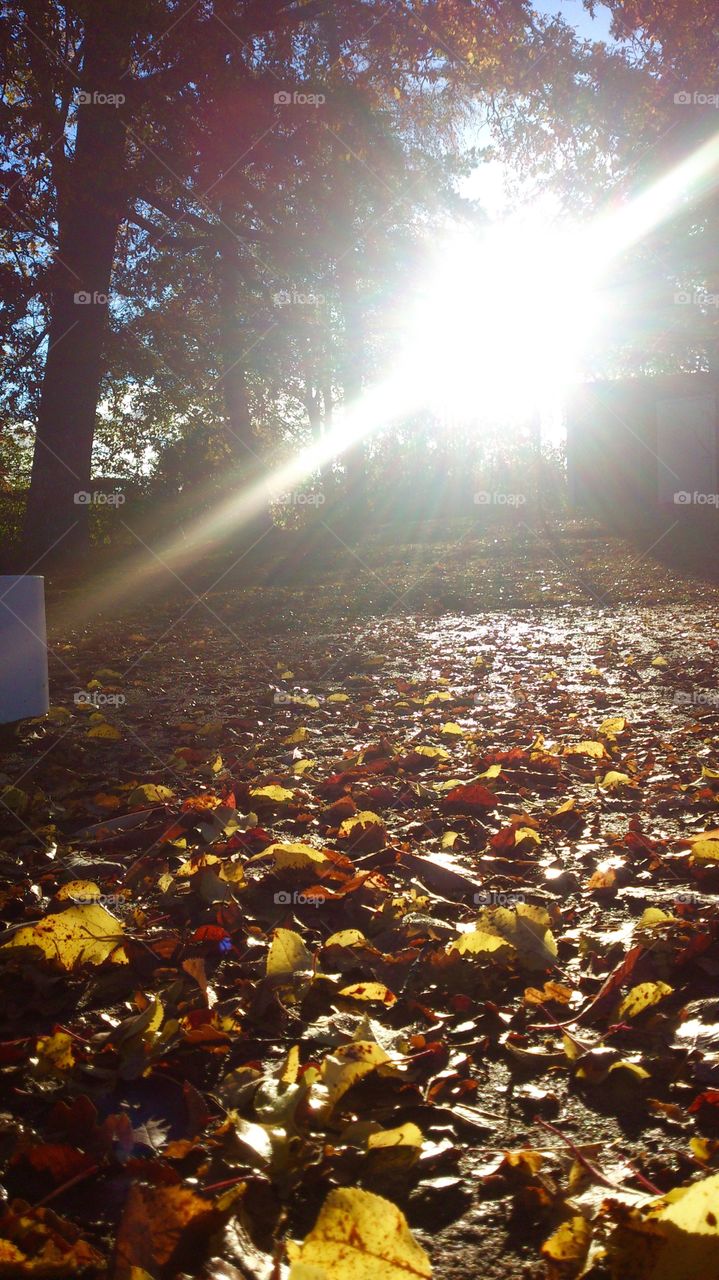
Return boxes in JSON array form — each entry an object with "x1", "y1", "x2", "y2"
[{"x1": 22, "y1": 0, "x2": 129, "y2": 564}]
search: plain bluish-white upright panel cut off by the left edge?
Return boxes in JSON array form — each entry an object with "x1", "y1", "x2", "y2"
[{"x1": 0, "y1": 573, "x2": 50, "y2": 724}]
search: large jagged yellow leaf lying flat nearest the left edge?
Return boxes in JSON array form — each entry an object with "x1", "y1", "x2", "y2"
[{"x1": 4, "y1": 904, "x2": 128, "y2": 969}]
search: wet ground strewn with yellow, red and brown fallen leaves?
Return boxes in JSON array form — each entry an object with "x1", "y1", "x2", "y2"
[{"x1": 0, "y1": 522, "x2": 719, "y2": 1280}]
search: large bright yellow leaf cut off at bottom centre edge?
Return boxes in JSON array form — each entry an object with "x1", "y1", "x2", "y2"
[{"x1": 288, "y1": 1187, "x2": 432, "y2": 1280}]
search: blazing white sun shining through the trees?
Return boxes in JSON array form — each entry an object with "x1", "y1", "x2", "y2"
[{"x1": 403, "y1": 216, "x2": 600, "y2": 425}]
